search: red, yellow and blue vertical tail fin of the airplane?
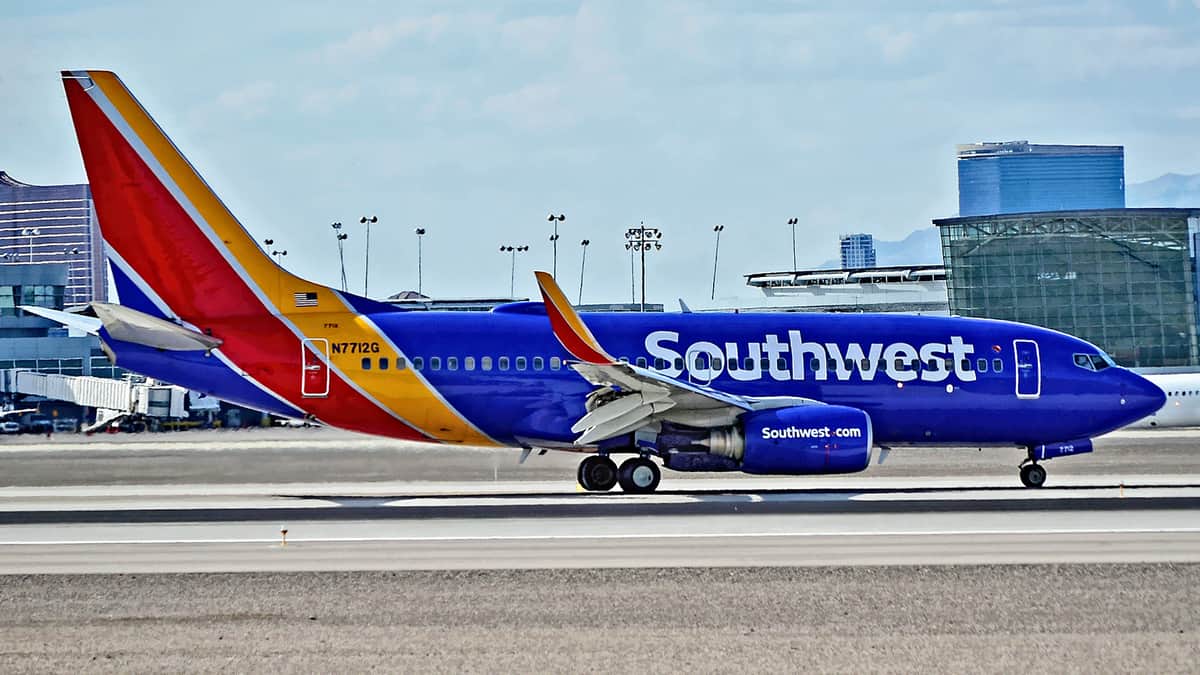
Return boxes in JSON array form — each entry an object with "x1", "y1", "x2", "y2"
[{"x1": 62, "y1": 71, "x2": 367, "y2": 325}]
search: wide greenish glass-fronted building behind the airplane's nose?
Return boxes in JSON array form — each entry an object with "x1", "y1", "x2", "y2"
[{"x1": 934, "y1": 209, "x2": 1200, "y2": 366}]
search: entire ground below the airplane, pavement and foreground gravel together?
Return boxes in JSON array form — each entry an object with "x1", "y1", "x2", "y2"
[{"x1": 0, "y1": 430, "x2": 1200, "y2": 673}]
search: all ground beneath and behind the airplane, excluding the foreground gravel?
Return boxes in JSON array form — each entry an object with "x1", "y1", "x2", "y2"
[{"x1": 0, "y1": 429, "x2": 1200, "y2": 574}]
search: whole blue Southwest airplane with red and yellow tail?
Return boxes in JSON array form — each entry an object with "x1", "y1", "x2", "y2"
[{"x1": 43, "y1": 71, "x2": 1164, "y2": 492}]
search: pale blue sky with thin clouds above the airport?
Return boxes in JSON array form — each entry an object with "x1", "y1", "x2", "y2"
[{"x1": 0, "y1": 0, "x2": 1200, "y2": 306}]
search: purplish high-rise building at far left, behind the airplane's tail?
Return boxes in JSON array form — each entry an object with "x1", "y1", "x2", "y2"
[{"x1": 0, "y1": 172, "x2": 108, "y2": 305}]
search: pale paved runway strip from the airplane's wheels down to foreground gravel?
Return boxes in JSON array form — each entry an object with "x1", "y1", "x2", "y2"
[{"x1": 0, "y1": 476, "x2": 1200, "y2": 574}]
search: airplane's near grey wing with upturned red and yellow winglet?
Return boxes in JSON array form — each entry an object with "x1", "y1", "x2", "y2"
[{"x1": 535, "y1": 271, "x2": 823, "y2": 446}]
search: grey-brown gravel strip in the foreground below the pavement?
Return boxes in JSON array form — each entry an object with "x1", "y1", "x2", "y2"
[{"x1": 0, "y1": 565, "x2": 1200, "y2": 673}]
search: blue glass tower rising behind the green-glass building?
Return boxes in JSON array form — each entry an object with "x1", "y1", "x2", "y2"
[{"x1": 958, "y1": 141, "x2": 1124, "y2": 216}]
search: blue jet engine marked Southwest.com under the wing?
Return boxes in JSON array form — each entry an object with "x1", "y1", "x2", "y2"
[{"x1": 708, "y1": 405, "x2": 871, "y2": 476}]
